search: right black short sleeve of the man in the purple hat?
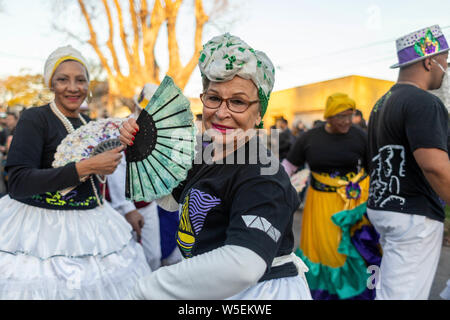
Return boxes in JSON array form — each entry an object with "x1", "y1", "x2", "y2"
[{"x1": 405, "y1": 102, "x2": 448, "y2": 152}]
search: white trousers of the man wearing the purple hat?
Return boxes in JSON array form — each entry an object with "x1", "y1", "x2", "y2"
[{"x1": 367, "y1": 209, "x2": 444, "y2": 300}]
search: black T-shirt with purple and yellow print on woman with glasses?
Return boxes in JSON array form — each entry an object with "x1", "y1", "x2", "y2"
[{"x1": 172, "y1": 138, "x2": 299, "y2": 281}]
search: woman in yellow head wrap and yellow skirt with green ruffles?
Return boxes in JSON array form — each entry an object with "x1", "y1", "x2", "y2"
[{"x1": 282, "y1": 93, "x2": 380, "y2": 299}]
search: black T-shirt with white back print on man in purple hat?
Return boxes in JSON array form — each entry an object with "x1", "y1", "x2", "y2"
[{"x1": 368, "y1": 84, "x2": 448, "y2": 221}]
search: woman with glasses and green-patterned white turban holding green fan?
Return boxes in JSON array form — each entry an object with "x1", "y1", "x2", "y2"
[{"x1": 120, "y1": 33, "x2": 311, "y2": 300}]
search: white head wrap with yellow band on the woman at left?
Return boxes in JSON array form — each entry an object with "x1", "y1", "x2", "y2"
[{"x1": 44, "y1": 45, "x2": 89, "y2": 88}]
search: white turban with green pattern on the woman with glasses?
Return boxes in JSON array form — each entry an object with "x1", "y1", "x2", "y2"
[{"x1": 198, "y1": 33, "x2": 275, "y2": 128}]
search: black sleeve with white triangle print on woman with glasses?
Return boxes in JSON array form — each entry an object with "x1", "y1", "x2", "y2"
[{"x1": 225, "y1": 177, "x2": 294, "y2": 268}]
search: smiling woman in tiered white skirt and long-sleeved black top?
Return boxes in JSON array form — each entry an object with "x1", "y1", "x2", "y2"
[{"x1": 0, "y1": 46, "x2": 150, "y2": 300}]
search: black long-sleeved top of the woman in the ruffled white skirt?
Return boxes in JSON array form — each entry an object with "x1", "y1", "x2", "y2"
[{"x1": 6, "y1": 105, "x2": 97, "y2": 210}]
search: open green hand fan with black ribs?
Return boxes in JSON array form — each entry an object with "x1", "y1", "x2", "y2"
[{"x1": 125, "y1": 76, "x2": 196, "y2": 202}]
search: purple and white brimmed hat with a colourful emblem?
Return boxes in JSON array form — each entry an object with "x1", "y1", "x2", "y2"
[{"x1": 391, "y1": 25, "x2": 450, "y2": 69}]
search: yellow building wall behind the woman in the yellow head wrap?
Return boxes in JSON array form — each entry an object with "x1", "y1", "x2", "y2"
[{"x1": 264, "y1": 75, "x2": 394, "y2": 128}]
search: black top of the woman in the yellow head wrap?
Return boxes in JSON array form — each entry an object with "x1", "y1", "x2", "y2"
[{"x1": 286, "y1": 125, "x2": 368, "y2": 176}]
